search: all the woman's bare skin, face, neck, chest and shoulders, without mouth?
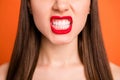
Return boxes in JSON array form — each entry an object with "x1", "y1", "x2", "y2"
[{"x1": 0, "y1": 0, "x2": 120, "y2": 80}]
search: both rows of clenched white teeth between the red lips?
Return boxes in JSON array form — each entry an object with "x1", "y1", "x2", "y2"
[{"x1": 52, "y1": 20, "x2": 70, "y2": 29}]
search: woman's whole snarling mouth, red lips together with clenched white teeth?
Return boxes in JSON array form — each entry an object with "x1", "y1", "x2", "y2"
[{"x1": 50, "y1": 16, "x2": 72, "y2": 34}]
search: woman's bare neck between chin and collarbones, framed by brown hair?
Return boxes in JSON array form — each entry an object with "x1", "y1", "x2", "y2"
[{"x1": 38, "y1": 38, "x2": 81, "y2": 66}]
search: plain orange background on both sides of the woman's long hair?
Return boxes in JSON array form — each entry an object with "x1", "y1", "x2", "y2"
[{"x1": 0, "y1": 0, "x2": 120, "y2": 66}]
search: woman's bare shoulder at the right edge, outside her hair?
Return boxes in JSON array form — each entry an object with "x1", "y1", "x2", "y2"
[{"x1": 110, "y1": 63, "x2": 120, "y2": 80}]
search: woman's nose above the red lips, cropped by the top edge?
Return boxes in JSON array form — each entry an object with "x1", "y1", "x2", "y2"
[{"x1": 53, "y1": 0, "x2": 69, "y2": 12}]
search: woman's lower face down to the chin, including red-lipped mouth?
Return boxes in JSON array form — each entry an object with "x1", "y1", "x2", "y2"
[{"x1": 30, "y1": 0, "x2": 90, "y2": 44}]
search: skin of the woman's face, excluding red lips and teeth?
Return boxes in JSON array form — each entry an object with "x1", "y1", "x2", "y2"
[{"x1": 30, "y1": 0, "x2": 90, "y2": 45}]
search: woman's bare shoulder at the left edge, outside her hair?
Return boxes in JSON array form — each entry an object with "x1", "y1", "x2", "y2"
[{"x1": 0, "y1": 63, "x2": 9, "y2": 80}]
